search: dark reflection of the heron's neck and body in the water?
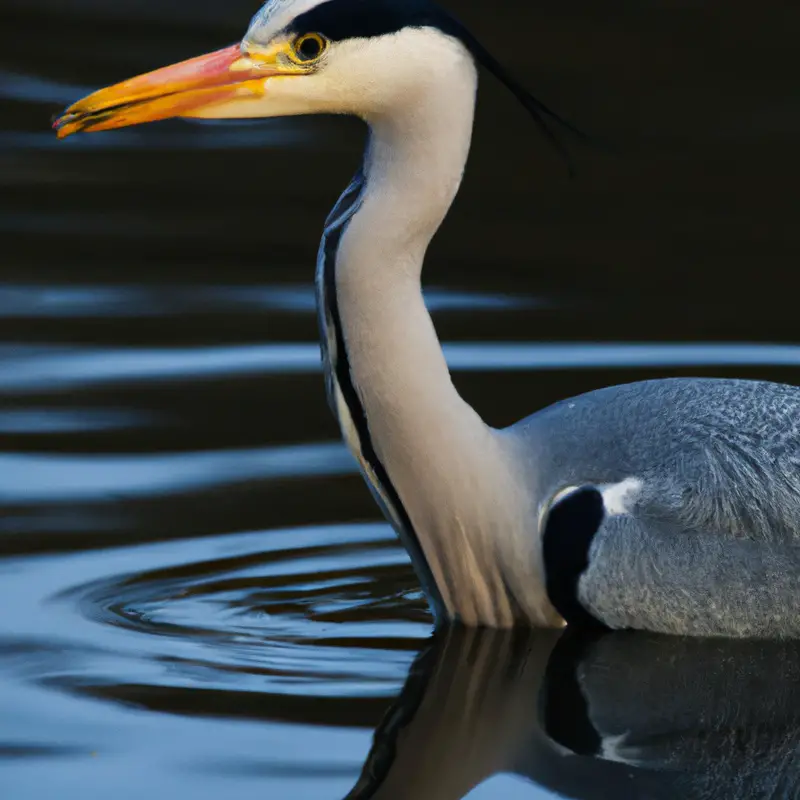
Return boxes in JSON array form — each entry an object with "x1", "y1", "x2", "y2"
[{"x1": 347, "y1": 629, "x2": 800, "y2": 800}]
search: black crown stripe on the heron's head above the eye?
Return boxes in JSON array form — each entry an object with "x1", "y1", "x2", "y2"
[{"x1": 289, "y1": 0, "x2": 461, "y2": 42}]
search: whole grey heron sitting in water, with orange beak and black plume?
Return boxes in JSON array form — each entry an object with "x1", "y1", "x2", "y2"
[{"x1": 55, "y1": 0, "x2": 800, "y2": 637}]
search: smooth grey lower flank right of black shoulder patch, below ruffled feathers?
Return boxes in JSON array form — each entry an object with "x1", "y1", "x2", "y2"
[{"x1": 579, "y1": 516, "x2": 800, "y2": 638}]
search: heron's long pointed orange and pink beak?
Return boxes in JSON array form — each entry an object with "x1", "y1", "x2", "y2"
[{"x1": 53, "y1": 44, "x2": 291, "y2": 139}]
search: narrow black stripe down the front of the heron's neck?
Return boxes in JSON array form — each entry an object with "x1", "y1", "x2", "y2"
[{"x1": 321, "y1": 171, "x2": 444, "y2": 621}]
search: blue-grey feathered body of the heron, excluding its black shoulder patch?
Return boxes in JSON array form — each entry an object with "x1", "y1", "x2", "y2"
[{"x1": 517, "y1": 379, "x2": 800, "y2": 637}]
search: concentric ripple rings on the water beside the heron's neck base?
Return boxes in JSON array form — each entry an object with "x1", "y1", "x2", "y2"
[{"x1": 47, "y1": 525, "x2": 430, "y2": 722}]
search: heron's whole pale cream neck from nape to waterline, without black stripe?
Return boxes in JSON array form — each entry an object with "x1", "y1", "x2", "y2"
[{"x1": 326, "y1": 28, "x2": 564, "y2": 625}]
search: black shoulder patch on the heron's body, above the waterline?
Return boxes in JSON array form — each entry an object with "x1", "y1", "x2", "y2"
[{"x1": 542, "y1": 486, "x2": 605, "y2": 627}]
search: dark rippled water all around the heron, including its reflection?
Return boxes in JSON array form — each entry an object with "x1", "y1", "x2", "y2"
[{"x1": 0, "y1": 0, "x2": 800, "y2": 800}]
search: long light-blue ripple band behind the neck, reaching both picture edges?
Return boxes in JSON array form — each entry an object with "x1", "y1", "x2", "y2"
[{"x1": 0, "y1": 342, "x2": 800, "y2": 393}]
